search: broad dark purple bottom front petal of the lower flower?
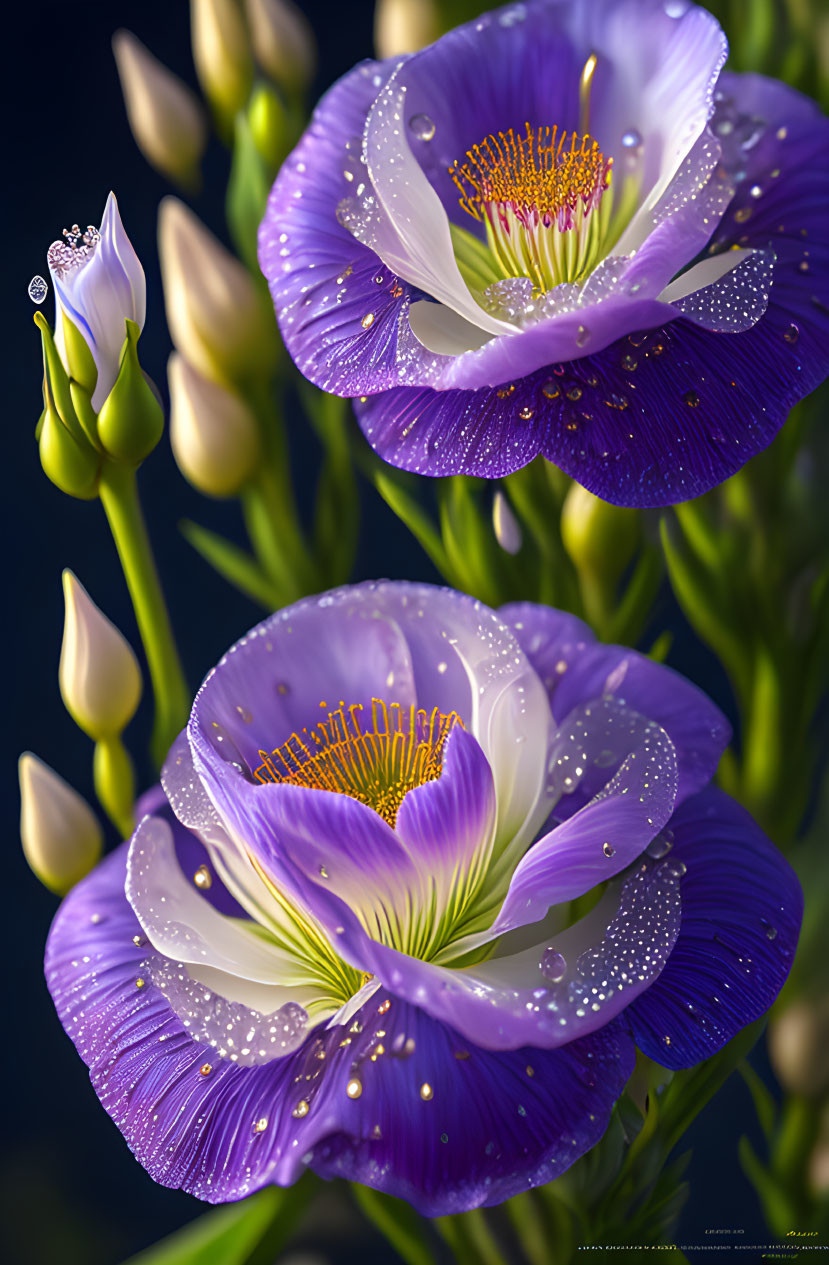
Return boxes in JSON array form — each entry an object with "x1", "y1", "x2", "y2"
[{"x1": 47, "y1": 848, "x2": 633, "y2": 1216}]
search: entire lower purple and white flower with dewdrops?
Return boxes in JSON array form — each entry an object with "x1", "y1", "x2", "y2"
[{"x1": 47, "y1": 583, "x2": 801, "y2": 1214}]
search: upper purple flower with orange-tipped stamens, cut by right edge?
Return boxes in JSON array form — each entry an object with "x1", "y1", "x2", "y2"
[{"x1": 259, "y1": 0, "x2": 829, "y2": 506}]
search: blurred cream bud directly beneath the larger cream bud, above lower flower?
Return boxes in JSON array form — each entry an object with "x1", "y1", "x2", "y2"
[{"x1": 167, "y1": 352, "x2": 259, "y2": 496}]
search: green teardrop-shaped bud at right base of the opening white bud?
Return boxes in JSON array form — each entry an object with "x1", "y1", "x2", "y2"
[{"x1": 97, "y1": 318, "x2": 165, "y2": 466}]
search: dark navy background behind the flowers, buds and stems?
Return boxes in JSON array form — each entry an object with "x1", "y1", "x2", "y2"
[{"x1": 0, "y1": 0, "x2": 779, "y2": 1265}]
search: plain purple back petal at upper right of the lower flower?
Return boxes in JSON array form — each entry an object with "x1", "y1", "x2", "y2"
[{"x1": 501, "y1": 602, "x2": 732, "y2": 802}]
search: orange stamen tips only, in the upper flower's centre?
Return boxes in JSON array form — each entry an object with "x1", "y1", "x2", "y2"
[{"x1": 449, "y1": 123, "x2": 613, "y2": 231}]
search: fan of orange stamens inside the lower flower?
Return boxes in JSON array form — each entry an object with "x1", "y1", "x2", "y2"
[{"x1": 254, "y1": 698, "x2": 462, "y2": 827}]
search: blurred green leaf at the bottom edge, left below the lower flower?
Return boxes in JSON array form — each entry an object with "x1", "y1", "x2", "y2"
[{"x1": 120, "y1": 1187, "x2": 305, "y2": 1265}]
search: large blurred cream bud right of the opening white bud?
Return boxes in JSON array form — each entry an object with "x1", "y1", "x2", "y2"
[{"x1": 158, "y1": 197, "x2": 277, "y2": 382}]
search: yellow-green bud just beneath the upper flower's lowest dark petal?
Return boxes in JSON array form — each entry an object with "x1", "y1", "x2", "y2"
[{"x1": 561, "y1": 483, "x2": 639, "y2": 578}]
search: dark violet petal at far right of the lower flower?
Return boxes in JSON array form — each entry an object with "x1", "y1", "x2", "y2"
[{"x1": 626, "y1": 787, "x2": 802, "y2": 1068}]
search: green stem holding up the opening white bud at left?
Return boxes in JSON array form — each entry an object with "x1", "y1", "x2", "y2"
[{"x1": 99, "y1": 462, "x2": 190, "y2": 765}]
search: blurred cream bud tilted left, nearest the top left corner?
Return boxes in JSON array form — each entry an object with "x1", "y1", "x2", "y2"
[{"x1": 113, "y1": 30, "x2": 208, "y2": 187}]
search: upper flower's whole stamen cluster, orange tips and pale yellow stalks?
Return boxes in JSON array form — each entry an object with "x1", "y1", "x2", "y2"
[{"x1": 449, "y1": 123, "x2": 613, "y2": 293}]
